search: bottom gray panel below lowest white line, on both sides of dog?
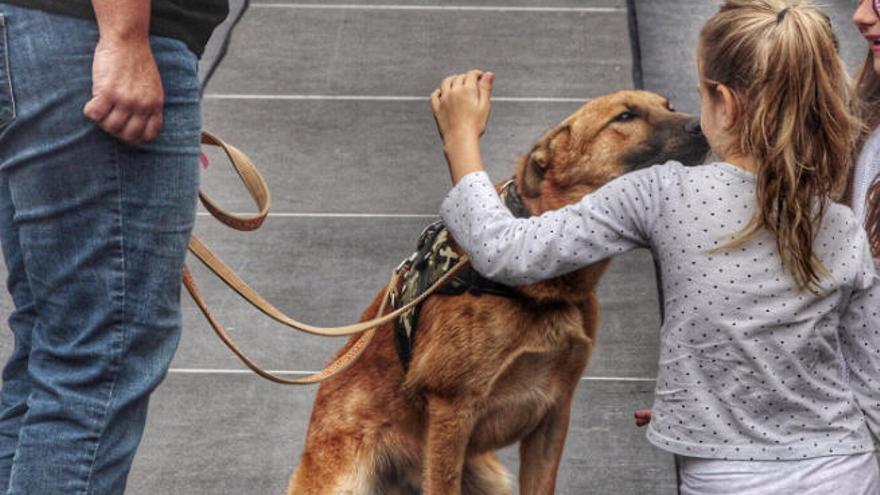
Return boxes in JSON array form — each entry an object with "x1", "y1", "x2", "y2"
[{"x1": 126, "y1": 374, "x2": 674, "y2": 495}]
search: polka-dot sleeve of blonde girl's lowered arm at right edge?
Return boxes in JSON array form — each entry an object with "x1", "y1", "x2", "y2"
[{"x1": 840, "y1": 232, "x2": 880, "y2": 438}]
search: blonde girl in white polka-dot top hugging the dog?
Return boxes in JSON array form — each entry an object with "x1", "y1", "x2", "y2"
[{"x1": 431, "y1": 0, "x2": 880, "y2": 495}]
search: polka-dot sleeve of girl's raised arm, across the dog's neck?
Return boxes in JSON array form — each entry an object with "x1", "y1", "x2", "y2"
[{"x1": 441, "y1": 167, "x2": 659, "y2": 285}]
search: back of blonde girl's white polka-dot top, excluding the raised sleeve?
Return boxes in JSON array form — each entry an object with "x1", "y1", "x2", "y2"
[{"x1": 633, "y1": 163, "x2": 873, "y2": 460}]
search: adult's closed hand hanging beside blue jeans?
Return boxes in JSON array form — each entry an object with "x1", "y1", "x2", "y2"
[{"x1": 83, "y1": 37, "x2": 165, "y2": 144}]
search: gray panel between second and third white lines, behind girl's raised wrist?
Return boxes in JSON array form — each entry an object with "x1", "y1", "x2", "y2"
[{"x1": 197, "y1": 99, "x2": 580, "y2": 215}]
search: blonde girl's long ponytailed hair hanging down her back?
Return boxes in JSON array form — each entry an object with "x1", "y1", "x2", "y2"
[{"x1": 697, "y1": 0, "x2": 859, "y2": 291}]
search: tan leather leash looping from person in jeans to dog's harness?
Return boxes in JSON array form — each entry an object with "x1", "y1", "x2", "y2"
[{"x1": 183, "y1": 131, "x2": 468, "y2": 385}]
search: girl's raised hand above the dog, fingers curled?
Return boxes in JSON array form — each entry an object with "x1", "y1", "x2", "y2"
[{"x1": 431, "y1": 70, "x2": 495, "y2": 145}]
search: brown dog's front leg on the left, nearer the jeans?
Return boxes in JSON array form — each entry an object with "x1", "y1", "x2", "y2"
[{"x1": 422, "y1": 396, "x2": 476, "y2": 495}]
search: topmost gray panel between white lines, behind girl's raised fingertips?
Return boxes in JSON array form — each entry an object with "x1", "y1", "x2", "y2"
[{"x1": 202, "y1": 2, "x2": 631, "y2": 98}]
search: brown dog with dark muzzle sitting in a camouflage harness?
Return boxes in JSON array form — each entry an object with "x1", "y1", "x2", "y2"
[{"x1": 290, "y1": 91, "x2": 708, "y2": 495}]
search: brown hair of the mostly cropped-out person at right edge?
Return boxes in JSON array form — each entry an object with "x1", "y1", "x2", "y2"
[{"x1": 847, "y1": 50, "x2": 880, "y2": 258}]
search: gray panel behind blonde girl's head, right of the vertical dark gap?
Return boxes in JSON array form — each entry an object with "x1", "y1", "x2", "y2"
[{"x1": 635, "y1": 0, "x2": 866, "y2": 113}]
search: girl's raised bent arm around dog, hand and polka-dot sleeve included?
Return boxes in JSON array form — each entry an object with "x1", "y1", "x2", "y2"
[{"x1": 431, "y1": 71, "x2": 662, "y2": 285}]
